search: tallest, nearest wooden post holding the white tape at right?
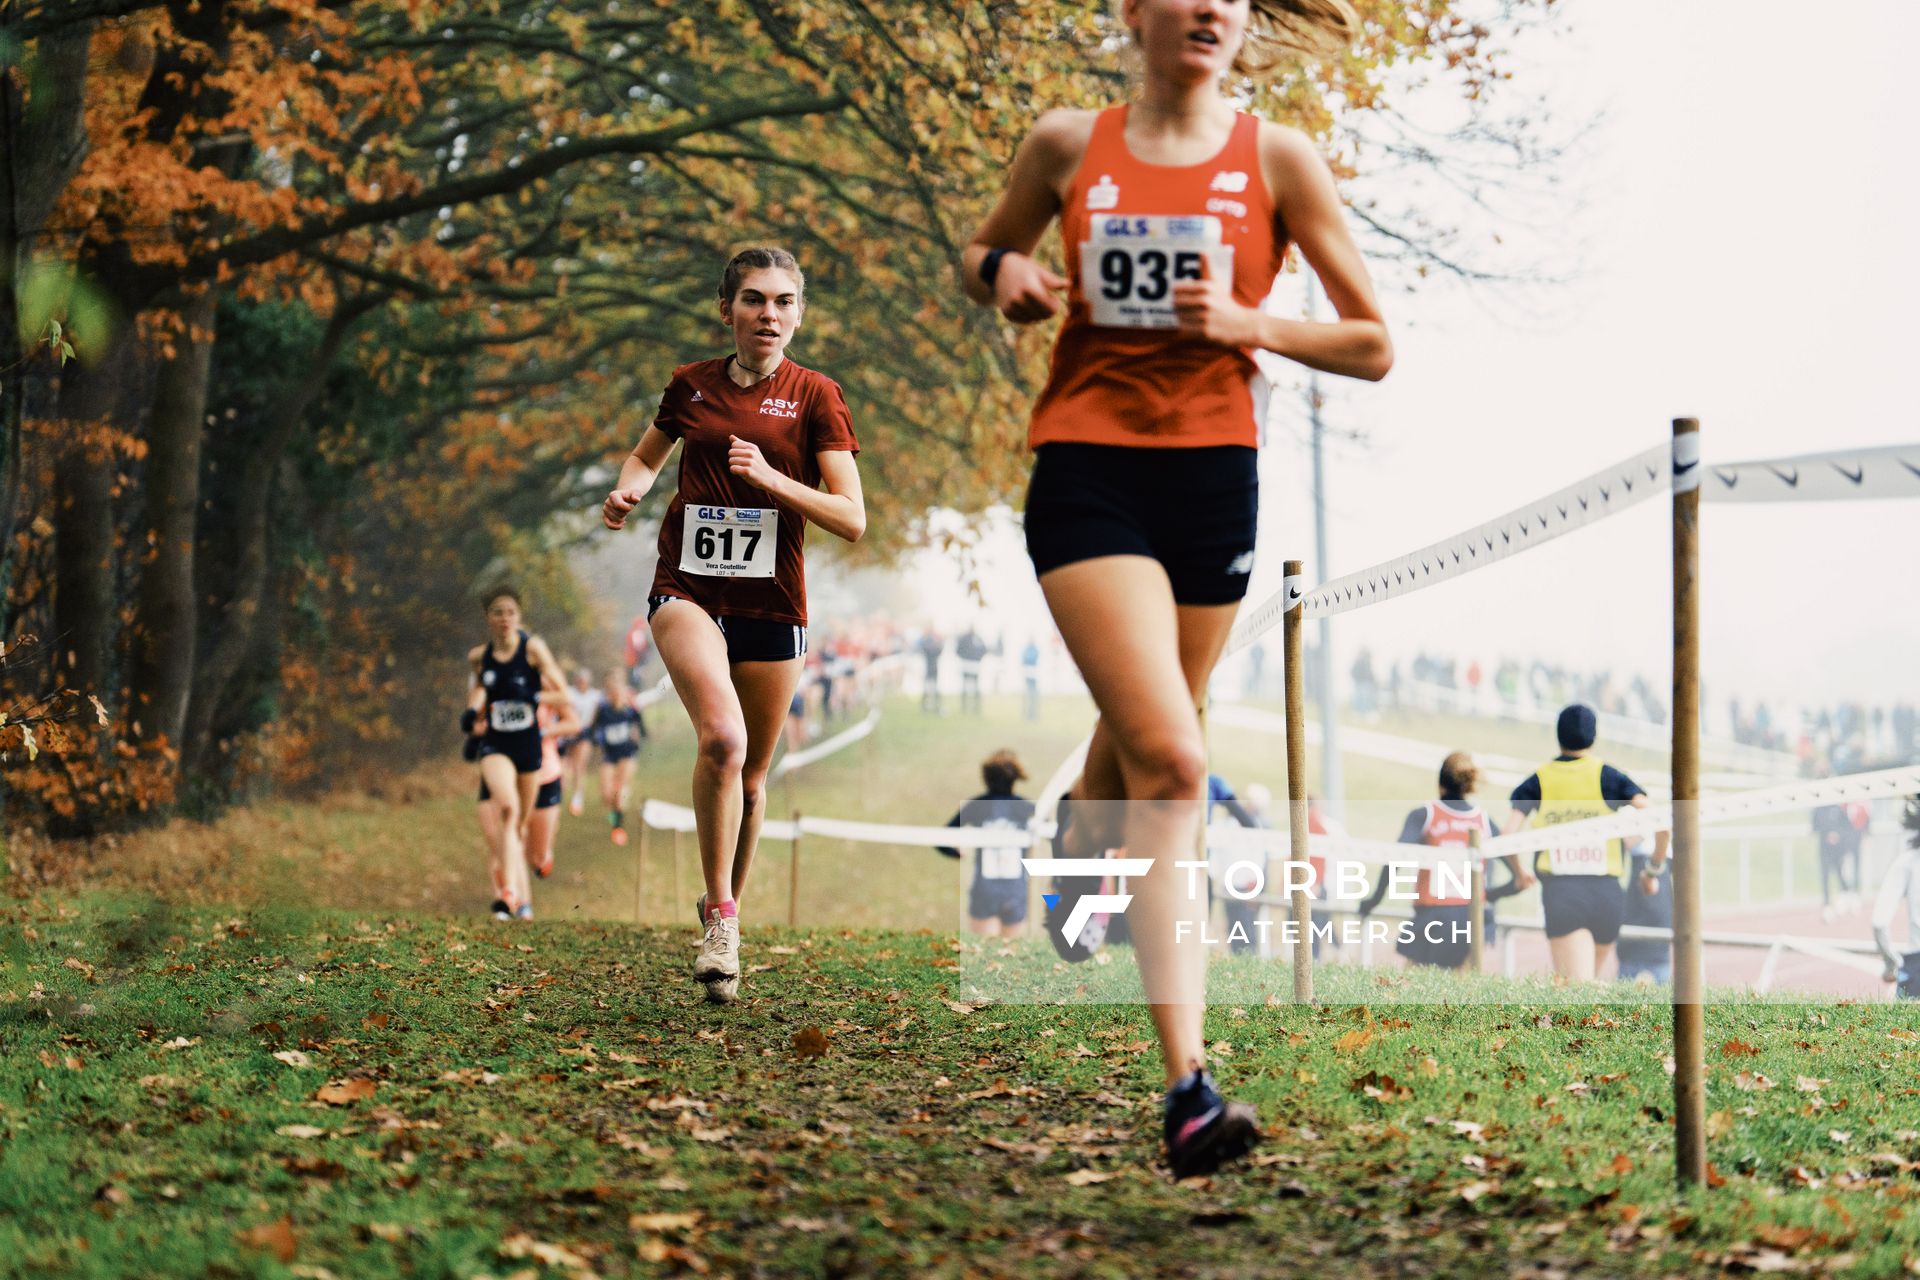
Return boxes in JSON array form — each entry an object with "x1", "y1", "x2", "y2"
[{"x1": 1668, "y1": 418, "x2": 1707, "y2": 1188}]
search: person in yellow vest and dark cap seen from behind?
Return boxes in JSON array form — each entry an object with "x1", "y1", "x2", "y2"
[{"x1": 1503, "y1": 702, "x2": 1668, "y2": 981}]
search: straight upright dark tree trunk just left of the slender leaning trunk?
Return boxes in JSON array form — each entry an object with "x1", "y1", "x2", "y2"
[{"x1": 129, "y1": 292, "x2": 213, "y2": 747}]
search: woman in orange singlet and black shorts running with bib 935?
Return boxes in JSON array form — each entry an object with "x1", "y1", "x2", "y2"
[{"x1": 962, "y1": 0, "x2": 1394, "y2": 1176}]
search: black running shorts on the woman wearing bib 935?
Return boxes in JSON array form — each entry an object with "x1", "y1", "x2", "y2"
[{"x1": 1027, "y1": 443, "x2": 1260, "y2": 604}]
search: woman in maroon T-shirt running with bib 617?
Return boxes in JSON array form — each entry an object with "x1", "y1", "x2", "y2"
[{"x1": 601, "y1": 249, "x2": 866, "y2": 1004}]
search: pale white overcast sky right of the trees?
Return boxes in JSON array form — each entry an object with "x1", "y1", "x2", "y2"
[{"x1": 898, "y1": 0, "x2": 1920, "y2": 721}]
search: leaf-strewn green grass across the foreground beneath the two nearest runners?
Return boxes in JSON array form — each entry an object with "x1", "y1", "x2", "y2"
[{"x1": 0, "y1": 890, "x2": 1920, "y2": 1280}]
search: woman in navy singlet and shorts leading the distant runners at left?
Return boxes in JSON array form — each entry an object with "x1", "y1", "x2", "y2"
[{"x1": 461, "y1": 587, "x2": 570, "y2": 915}]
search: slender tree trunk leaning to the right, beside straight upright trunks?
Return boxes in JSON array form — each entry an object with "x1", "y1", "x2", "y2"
[{"x1": 184, "y1": 297, "x2": 378, "y2": 771}]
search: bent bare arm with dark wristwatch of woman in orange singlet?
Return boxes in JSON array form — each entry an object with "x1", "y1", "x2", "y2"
[{"x1": 960, "y1": 111, "x2": 1096, "y2": 324}]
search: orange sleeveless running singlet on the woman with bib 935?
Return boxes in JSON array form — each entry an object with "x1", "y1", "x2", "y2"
[{"x1": 1027, "y1": 106, "x2": 1286, "y2": 447}]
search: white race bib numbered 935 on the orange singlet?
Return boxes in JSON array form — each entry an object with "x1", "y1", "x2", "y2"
[{"x1": 1081, "y1": 213, "x2": 1233, "y2": 328}]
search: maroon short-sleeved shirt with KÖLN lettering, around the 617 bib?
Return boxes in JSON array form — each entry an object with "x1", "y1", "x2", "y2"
[{"x1": 649, "y1": 357, "x2": 860, "y2": 626}]
